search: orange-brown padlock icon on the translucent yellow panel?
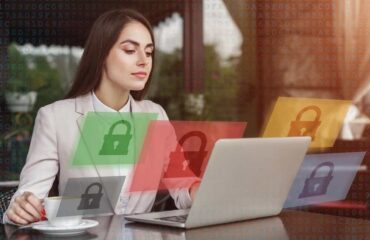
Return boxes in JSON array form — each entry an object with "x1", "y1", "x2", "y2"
[{"x1": 288, "y1": 105, "x2": 321, "y2": 141}]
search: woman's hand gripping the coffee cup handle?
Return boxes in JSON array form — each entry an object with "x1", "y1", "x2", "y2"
[{"x1": 6, "y1": 192, "x2": 43, "y2": 225}]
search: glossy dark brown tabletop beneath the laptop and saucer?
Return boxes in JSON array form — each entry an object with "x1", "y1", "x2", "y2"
[{"x1": 0, "y1": 210, "x2": 370, "y2": 240}]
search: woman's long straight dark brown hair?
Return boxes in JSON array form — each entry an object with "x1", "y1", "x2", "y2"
[{"x1": 66, "y1": 9, "x2": 154, "y2": 100}]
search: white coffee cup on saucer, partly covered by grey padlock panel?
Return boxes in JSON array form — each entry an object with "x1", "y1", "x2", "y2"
[{"x1": 44, "y1": 196, "x2": 82, "y2": 227}]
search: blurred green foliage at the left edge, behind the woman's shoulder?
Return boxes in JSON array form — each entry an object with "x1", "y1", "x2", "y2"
[{"x1": 0, "y1": 43, "x2": 64, "y2": 173}]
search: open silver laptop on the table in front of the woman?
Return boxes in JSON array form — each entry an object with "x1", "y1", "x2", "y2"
[{"x1": 125, "y1": 137, "x2": 311, "y2": 228}]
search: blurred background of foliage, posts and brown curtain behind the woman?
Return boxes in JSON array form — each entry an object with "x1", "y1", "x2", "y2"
[{"x1": 0, "y1": 0, "x2": 370, "y2": 217}]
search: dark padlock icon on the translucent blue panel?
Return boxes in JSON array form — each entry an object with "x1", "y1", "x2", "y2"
[{"x1": 298, "y1": 162, "x2": 334, "y2": 198}]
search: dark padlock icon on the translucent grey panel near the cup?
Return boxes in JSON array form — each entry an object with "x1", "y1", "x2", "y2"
[{"x1": 77, "y1": 182, "x2": 103, "y2": 210}]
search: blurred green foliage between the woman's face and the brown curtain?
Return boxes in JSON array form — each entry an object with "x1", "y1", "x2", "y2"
[{"x1": 149, "y1": 45, "x2": 239, "y2": 120}]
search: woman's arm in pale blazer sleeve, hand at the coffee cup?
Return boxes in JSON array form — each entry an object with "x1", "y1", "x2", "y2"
[{"x1": 3, "y1": 105, "x2": 59, "y2": 224}]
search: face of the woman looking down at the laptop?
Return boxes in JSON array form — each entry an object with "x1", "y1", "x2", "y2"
[{"x1": 102, "y1": 21, "x2": 154, "y2": 91}]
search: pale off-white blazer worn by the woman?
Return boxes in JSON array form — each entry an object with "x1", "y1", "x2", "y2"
[{"x1": 3, "y1": 93, "x2": 191, "y2": 223}]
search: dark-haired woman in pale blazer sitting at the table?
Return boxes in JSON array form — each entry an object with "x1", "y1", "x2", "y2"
[{"x1": 4, "y1": 9, "x2": 196, "y2": 224}]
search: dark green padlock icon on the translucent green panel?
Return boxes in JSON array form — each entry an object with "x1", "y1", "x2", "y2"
[{"x1": 99, "y1": 120, "x2": 132, "y2": 155}]
